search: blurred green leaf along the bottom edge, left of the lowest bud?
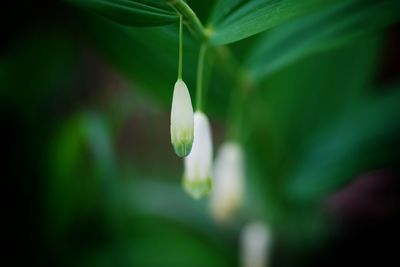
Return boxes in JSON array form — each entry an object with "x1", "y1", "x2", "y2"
[{"x1": 77, "y1": 216, "x2": 235, "y2": 267}]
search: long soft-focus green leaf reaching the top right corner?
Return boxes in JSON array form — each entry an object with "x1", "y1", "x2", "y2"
[{"x1": 246, "y1": 0, "x2": 400, "y2": 80}]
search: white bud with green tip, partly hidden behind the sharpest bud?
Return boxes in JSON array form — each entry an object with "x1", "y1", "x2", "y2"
[{"x1": 183, "y1": 111, "x2": 213, "y2": 199}]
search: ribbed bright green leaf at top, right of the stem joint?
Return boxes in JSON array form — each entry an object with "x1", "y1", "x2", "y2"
[{"x1": 210, "y1": 0, "x2": 335, "y2": 45}]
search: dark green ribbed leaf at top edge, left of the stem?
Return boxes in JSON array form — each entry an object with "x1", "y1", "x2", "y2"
[{"x1": 69, "y1": 0, "x2": 178, "y2": 26}]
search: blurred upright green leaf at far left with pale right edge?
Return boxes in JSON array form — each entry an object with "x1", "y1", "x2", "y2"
[{"x1": 46, "y1": 112, "x2": 115, "y2": 237}]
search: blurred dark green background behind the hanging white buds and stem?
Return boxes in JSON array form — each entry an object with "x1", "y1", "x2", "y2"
[{"x1": 0, "y1": 0, "x2": 400, "y2": 267}]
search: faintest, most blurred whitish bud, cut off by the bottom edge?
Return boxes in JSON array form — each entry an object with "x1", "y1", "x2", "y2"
[{"x1": 240, "y1": 222, "x2": 271, "y2": 267}]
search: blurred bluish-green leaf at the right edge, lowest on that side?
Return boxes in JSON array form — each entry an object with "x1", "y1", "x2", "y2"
[{"x1": 288, "y1": 86, "x2": 400, "y2": 203}]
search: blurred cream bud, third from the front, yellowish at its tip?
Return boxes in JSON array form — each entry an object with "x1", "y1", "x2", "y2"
[{"x1": 210, "y1": 143, "x2": 244, "y2": 221}]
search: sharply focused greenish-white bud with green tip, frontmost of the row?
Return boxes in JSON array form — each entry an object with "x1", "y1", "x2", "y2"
[{"x1": 171, "y1": 79, "x2": 193, "y2": 157}]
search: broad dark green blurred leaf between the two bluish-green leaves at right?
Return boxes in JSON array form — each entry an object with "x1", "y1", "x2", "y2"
[{"x1": 245, "y1": 36, "x2": 381, "y2": 224}]
